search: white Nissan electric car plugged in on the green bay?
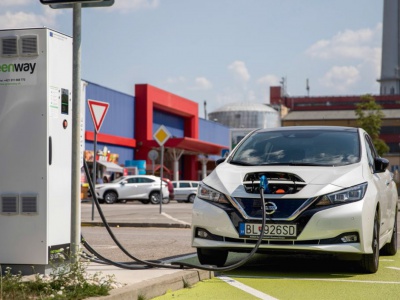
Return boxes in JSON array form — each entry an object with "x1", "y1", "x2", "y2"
[{"x1": 192, "y1": 126, "x2": 398, "y2": 273}]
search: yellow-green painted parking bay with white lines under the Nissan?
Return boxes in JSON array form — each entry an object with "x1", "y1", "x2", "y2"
[{"x1": 156, "y1": 253, "x2": 400, "y2": 300}]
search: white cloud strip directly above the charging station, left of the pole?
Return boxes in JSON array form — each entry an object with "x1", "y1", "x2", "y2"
[{"x1": 0, "y1": 10, "x2": 58, "y2": 29}]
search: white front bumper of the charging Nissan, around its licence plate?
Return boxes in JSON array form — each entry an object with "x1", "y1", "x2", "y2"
[{"x1": 192, "y1": 198, "x2": 372, "y2": 254}]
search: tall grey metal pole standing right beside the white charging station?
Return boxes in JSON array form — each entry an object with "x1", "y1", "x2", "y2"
[{"x1": 70, "y1": 3, "x2": 82, "y2": 263}]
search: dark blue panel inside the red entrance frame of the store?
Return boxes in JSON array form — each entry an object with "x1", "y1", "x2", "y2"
[{"x1": 153, "y1": 109, "x2": 185, "y2": 138}]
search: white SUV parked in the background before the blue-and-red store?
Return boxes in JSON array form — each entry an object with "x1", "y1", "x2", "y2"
[{"x1": 95, "y1": 175, "x2": 169, "y2": 204}]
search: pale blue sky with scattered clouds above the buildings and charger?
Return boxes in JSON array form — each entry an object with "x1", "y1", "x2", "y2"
[{"x1": 0, "y1": 0, "x2": 383, "y2": 118}]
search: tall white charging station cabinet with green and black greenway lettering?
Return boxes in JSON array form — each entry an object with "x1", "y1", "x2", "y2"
[{"x1": 0, "y1": 28, "x2": 73, "y2": 273}]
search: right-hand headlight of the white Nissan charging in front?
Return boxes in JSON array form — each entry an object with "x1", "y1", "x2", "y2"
[{"x1": 316, "y1": 182, "x2": 368, "y2": 206}]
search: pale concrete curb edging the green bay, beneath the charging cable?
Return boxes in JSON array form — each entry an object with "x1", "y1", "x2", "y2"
[{"x1": 88, "y1": 270, "x2": 214, "y2": 300}]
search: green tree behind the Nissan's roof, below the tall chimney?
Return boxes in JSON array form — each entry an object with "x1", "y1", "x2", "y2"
[{"x1": 355, "y1": 95, "x2": 390, "y2": 156}]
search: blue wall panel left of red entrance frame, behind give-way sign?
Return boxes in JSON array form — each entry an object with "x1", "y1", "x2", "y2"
[{"x1": 85, "y1": 81, "x2": 135, "y2": 138}]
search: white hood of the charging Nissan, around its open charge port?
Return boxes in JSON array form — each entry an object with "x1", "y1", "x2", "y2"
[{"x1": 203, "y1": 162, "x2": 366, "y2": 198}]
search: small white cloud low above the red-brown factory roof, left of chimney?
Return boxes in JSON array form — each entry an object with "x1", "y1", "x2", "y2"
[{"x1": 319, "y1": 66, "x2": 360, "y2": 92}]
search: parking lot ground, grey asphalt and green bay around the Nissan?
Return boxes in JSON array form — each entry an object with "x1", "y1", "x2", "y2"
[{"x1": 82, "y1": 202, "x2": 400, "y2": 299}]
